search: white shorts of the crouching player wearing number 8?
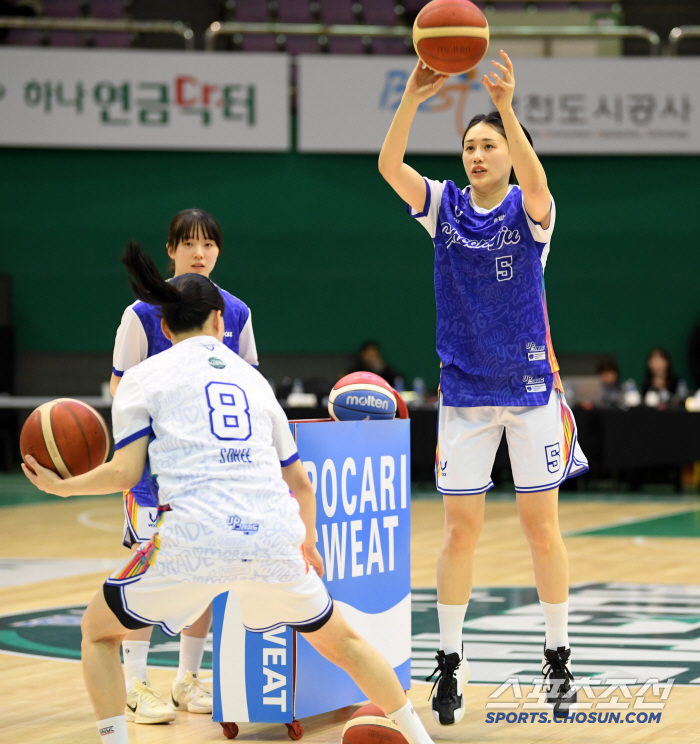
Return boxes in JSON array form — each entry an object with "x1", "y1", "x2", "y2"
[{"x1": 104, "y1": 542, "x2": 333, "y2": 635}]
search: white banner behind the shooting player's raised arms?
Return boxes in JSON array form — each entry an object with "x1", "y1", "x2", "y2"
[{"x1": 298, "y1": 56, "x2": 700, "y2": 155}]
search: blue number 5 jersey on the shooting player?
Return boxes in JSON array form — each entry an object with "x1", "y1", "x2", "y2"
[{"x1": 408, "y1": 179, "x2": 559, "y2": 407}]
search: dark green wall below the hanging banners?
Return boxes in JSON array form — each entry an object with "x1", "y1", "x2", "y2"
[{"x1": 0, "y1": 149, "x2": 700, "y2": 384}]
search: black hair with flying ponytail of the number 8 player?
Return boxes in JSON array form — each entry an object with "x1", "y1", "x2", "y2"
[{"x1": 121, "y1": 240, "x2": 225, "y2": 333}]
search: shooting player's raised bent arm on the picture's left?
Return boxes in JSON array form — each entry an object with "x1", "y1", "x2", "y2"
[{"x1": 379, "y1": 61, "x2": 447, "y2": 212}]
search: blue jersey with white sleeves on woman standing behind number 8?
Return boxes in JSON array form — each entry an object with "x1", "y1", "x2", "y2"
[{"x1": 112, "y1": 287, "x2": 257, "y2": 507}]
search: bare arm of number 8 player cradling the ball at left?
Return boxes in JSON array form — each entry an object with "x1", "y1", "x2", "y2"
[{"x1": 22, "y1": 435, "x2": 148, "y2": 497}]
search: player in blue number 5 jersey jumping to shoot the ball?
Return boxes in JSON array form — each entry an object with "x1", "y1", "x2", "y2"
[{"x1": 379, "y1": 51, "x2": 588, "y2": 725}]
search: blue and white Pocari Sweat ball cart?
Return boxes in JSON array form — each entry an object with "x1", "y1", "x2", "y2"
[{"x1": 214, "y1": 419, "x2": 411, "y2": 723}]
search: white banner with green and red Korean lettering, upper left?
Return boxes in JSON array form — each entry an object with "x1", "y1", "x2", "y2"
[{"x1": 0, "y1": 49, "x2": 289, "y2": 151}]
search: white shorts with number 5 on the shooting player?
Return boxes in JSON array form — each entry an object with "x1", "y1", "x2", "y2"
[{"x1": 435, "y1": 389, "x2": 588, "y2": 496}]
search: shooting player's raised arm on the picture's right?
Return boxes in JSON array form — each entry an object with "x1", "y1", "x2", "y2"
[{"x1": 482, "y1": 49, "x2": 552, "y2": 229}]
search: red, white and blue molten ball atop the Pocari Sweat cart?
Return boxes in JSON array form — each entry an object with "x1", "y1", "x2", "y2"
[{"x1": 328, "y1": 372, "x2": 408, "y2": 421}]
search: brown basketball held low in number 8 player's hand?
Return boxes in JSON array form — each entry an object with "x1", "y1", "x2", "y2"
[{"x1": 19, "y1": 398, "x2": 109, "y2": 478}]
